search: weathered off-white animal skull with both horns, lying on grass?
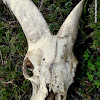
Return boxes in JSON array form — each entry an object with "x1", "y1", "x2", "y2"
[{"x1": 3, "y1": 0, "x2": 85, "y2": 100}]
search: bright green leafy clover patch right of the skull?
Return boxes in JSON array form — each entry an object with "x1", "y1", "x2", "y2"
[{"x1": 83, "y1": 49, "x2": 100, "y2": 88}]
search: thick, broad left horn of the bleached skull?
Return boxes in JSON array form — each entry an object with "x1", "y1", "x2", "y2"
[{"x1": 3, "y1": 0, "x2": 50, "y2": 43}]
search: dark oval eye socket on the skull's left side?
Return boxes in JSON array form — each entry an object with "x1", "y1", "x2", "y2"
[{"x1": 23, "y1": 58, "x2": 34, "y2": 78}]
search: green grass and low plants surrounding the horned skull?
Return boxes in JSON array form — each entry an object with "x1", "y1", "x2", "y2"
[{"x1": 0, "y1": 0, "x2": 100, "y2": 100}]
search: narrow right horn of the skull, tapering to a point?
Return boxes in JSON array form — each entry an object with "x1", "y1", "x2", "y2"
[{"x1": 58, "y1": 0, "x2": 85, "y2": 41}]
